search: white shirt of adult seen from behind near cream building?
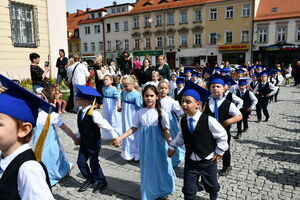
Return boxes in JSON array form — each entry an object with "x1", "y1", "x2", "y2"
[{"x1": 67, "y1": 62, "x2": 90, "y2": 85}]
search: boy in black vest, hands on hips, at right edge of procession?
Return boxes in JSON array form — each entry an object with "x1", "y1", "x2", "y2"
[{"x1": 253, "y1": 71, "x2": 277, "y2": 123}]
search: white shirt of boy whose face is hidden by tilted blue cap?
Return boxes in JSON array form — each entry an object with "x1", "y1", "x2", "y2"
[{"x1": 78, "y1": 105, "x2": 118, "y2": 139}]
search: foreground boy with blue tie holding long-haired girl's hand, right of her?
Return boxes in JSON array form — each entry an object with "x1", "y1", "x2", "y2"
[{"x1": 168, "y1": 82, "x2": 228, "y2": 200}]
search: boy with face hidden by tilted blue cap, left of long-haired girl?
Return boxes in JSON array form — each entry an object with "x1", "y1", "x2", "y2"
[{"x1": 76, "y1": 85, "x2": 118, "y2": 193}]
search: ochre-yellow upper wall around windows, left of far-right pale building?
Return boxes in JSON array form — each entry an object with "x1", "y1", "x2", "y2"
[{"x1": 202, "y1": 0, "x2": 253, "y2": 45}]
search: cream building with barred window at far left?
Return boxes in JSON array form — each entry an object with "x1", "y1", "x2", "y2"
[{"x1": 0, "y1": 0, "x2": 68, "y2": 80}]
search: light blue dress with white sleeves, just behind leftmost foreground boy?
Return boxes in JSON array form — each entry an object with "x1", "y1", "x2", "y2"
[{"x1": 33, "y1": 111, "x2": 72, "y2": 186}]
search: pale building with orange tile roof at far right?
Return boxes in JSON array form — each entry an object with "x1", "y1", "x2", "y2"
[{"x1": 253, "y1": 0, "x2": 300, "y2": 65}]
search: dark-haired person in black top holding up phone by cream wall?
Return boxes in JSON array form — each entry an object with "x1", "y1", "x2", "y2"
[{"x1": 29, "y1": 53, "x2": 49, "y2": 93}]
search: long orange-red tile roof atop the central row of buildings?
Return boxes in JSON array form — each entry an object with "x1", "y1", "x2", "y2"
[{"x1": 130, "y1": 0, "x2": 225, "y2": 14}]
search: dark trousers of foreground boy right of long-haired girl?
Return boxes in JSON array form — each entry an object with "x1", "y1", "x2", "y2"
[{"x1": 182, "y1": 157, "x2": 220, "y2": 200}]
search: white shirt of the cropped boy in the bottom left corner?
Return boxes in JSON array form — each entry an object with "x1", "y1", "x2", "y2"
[{"x1": 0, "y1": 144, "x2": 54, "y2": 200}]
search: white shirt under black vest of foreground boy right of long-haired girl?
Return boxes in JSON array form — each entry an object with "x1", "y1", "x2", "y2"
[{"x1": 169, "y1": 111, "x2": 228, "y2": 161}]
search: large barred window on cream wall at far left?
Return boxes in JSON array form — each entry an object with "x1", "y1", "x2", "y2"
[{"x1": 9, "y1": 1, "x2": 38, "y2": 47}]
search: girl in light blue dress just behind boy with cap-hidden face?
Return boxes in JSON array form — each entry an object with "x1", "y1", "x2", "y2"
[{"x1": 102, "y1": 75, "x2": 122, "y2": 139}]
